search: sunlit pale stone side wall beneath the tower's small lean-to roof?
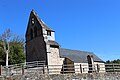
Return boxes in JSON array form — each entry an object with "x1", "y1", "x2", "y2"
[{"x1": 47, "y1": 47, "x2": 64, "y2": 74}]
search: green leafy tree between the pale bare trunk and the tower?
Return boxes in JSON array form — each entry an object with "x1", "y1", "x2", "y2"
[{"x1": 9, "y1": 42, "x2": 25, "y2": 64}]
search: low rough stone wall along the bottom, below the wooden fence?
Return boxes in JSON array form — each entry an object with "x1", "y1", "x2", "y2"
[{"x1": 0, "y1": 73, "x2": 120, "y2": 80}]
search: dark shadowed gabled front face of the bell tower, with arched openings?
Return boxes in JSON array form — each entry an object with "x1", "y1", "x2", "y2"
[{"x1": 25, "y1": 10, "x2": 47, "y2": 63}]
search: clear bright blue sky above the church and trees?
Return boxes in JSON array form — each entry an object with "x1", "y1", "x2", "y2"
[{"x1": 0, "y1": 0, "x2": 120, "y2": 60}]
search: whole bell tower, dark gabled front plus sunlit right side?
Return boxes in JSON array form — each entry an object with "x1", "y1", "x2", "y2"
[{"x1": 26, "y1": 10, "x2": 63, "y2": 65}]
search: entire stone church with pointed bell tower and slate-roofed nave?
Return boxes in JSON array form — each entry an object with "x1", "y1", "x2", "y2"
[{"x1": 25, "y1": 10, "x2": 105, "y2": 73}]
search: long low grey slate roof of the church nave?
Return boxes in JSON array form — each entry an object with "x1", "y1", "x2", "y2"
[{"x1": 60, "y1": 48, "x2": 104, "y2": 63}]
